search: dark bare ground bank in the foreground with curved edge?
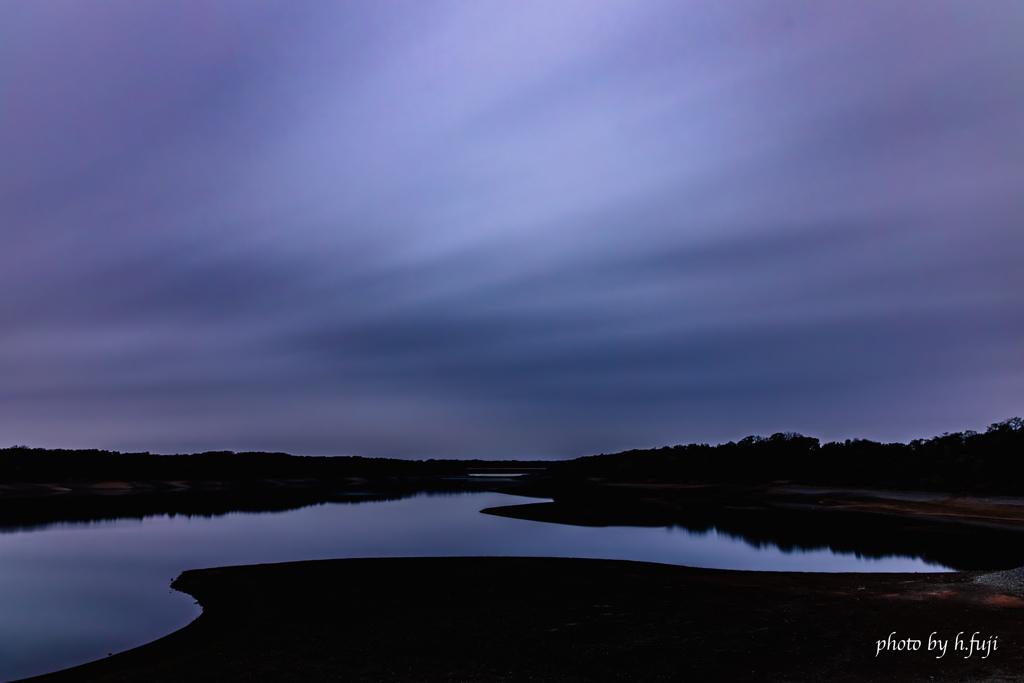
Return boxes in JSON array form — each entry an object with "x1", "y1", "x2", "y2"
[{"x1": 19, "y1": 558, "x2": 1024, "y2": 683}]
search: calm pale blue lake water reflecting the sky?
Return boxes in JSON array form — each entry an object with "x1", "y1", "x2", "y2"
[{"x1": 0, "y1": 493, "x2": 945, "y2": 681}]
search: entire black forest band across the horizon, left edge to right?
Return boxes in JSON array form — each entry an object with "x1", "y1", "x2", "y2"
[{"x1": 0, "y1": 418, "x2": 1024, "y2": 494}]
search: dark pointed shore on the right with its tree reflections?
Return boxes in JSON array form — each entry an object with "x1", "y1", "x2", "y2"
[{"x1": 481, "y1": 480, "x2": 1024, "y2": 571}]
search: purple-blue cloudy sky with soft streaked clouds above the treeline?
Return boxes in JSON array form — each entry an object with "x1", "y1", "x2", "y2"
[{"x1": 0, "y1": 0, "x2": 1024, "y2": 458}]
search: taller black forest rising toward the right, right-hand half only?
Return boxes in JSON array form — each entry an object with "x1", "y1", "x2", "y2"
[{"x1": 549, "y1": 418, "x2": 1024, "y2": 494}]
